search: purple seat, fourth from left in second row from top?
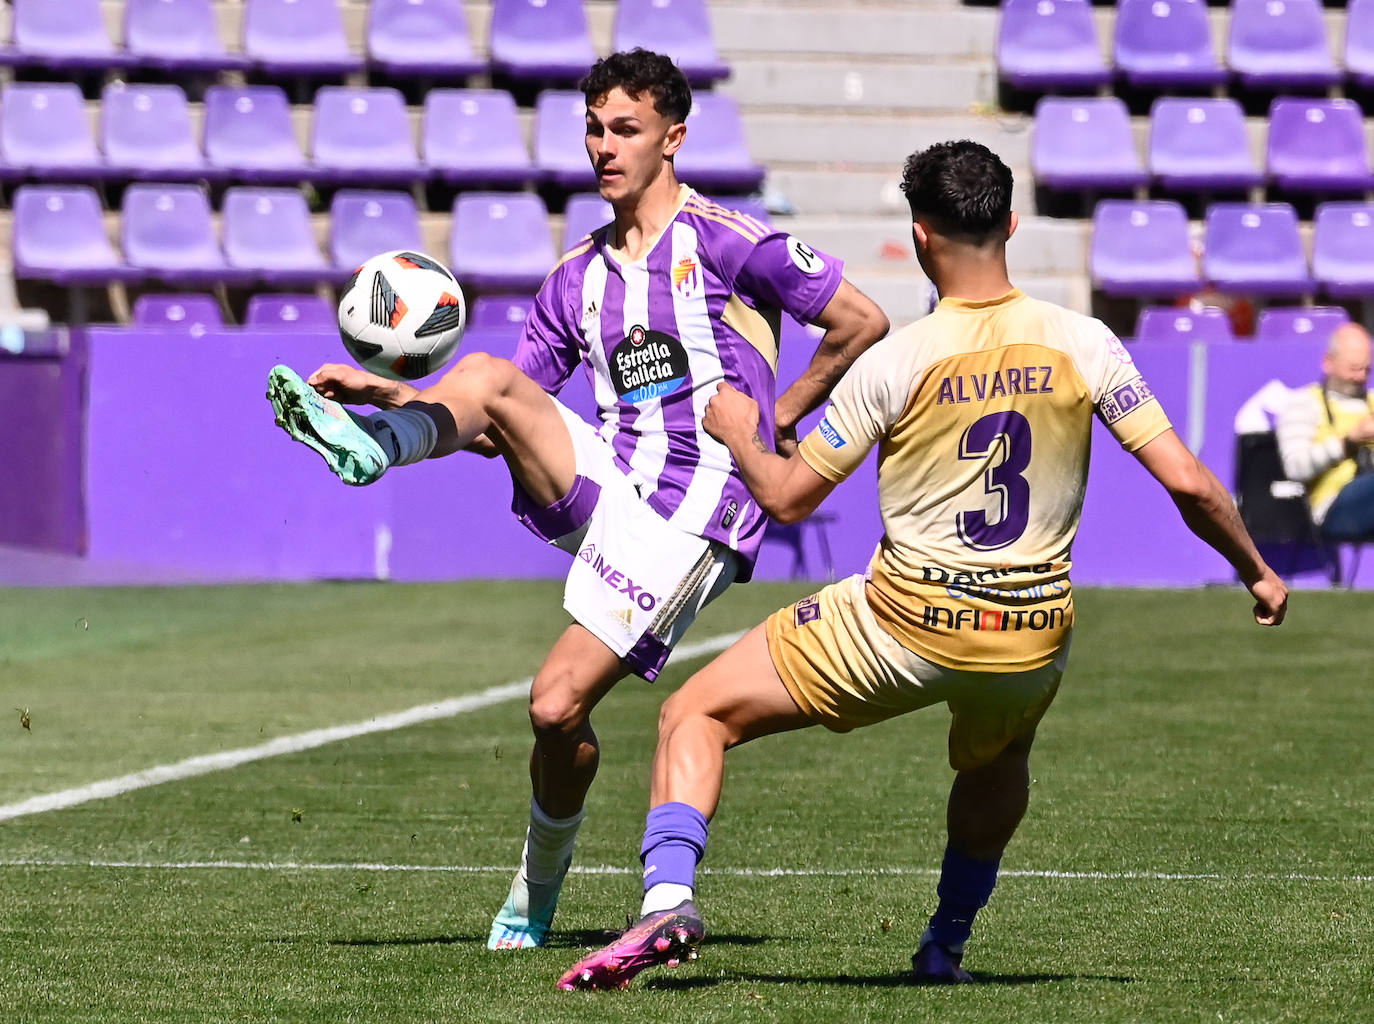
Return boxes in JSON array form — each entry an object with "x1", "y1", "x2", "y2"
[{"x1": 311, "y1": 85, "x2": 429, "y2": 184}]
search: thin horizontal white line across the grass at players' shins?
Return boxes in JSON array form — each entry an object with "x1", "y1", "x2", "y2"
[{"x1": 0, "y1": 859, "x2": 1374, "y2": 884}]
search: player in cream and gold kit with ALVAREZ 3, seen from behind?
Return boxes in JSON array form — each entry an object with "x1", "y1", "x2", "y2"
[{"x1": 559, "y1": 142, "x2": 1287, "y2": 988}]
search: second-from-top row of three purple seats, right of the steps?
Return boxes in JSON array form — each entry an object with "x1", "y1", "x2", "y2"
[{"x1": 1031, "y1": 96, "x2": 1374, "y2": 194}]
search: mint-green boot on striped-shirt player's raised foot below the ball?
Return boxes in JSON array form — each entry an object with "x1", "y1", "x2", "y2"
[{"x1": 267, "y1": 366, "x2": 389, "y2": 487}]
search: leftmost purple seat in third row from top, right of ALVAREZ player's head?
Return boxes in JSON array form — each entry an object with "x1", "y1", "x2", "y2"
[{"x1": 1090, "y1": 199, "x2": 1200, "y2": 297}]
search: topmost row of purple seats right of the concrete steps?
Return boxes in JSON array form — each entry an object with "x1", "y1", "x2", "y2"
[{"x1": 996, "y1": 0, "x2": 1374, "y2": 91}]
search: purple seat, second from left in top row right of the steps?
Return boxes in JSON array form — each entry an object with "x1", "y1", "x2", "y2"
[{"x1": 1114, "y1": 0, "x2": 1226, "y2": 88}]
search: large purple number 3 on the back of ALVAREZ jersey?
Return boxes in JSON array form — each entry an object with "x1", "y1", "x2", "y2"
[{"x1": 955, "y1": 410, "x2": 1031, "y2": 551}]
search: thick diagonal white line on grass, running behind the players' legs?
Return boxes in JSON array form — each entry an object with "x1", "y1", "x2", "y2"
[{"x1": 0, "y1": 631, "x2": 745, "y2": 822}]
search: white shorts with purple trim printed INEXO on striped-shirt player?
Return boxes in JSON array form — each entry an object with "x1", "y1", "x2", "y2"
[{"x1": 511, "y1": 399, "x2": 739, "y2": 682}]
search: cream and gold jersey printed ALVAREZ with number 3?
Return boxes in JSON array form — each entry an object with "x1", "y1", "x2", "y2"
[{"x1": 800, "y1": 290, "x2": 1169, "y2": 672}]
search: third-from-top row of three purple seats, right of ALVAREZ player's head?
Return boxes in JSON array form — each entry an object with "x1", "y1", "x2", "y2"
[{"x1": 1090, "y1": 199, "x2": 1374, "y2": 298}]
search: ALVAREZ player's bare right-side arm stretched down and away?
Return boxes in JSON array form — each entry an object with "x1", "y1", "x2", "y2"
[{"x1": 1135, "y1": 430, "x2": 1287, "y2": 625}]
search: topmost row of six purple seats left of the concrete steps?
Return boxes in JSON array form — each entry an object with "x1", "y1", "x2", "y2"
[{"x1": 0, "y1": 0, "x2": 730, "y2": 84}]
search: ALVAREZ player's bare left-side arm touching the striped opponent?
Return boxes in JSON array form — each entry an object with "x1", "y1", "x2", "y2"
[{"x1": 702, "y1": 382, "x2": 835, "y2": 522}]
